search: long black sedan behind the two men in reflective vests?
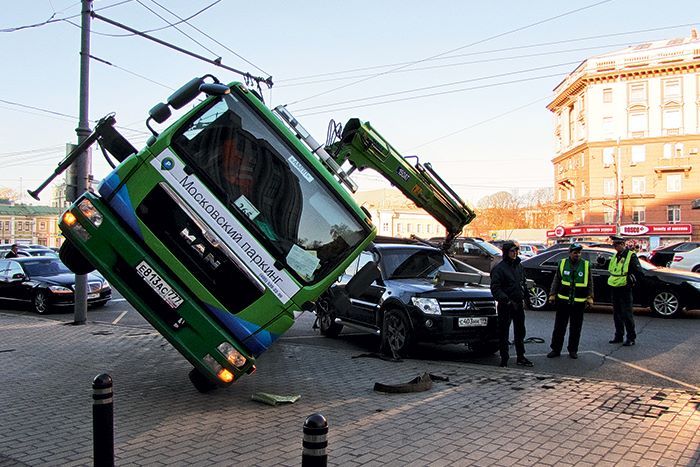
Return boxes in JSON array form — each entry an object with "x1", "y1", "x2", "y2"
[{"x1": 522, "y1": 247, "x2": 700, "y2": 317}]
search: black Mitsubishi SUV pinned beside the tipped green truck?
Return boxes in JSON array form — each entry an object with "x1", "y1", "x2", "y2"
[{"x1": 316, "y1": 242, "x2": 498, "y2": 356}]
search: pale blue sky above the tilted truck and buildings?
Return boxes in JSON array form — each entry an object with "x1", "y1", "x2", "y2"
[{"x1": 0, "y1": 0, "x2": 700, "y2": 204}]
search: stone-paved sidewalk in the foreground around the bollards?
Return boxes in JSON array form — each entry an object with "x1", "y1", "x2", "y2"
[{"x1": 0, "y1": 313, "x2": 700, "y2": 466}]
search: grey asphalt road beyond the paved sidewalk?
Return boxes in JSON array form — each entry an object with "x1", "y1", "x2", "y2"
[{"x1": 0, "y1": 293, "x2": 700, "y2": 391}]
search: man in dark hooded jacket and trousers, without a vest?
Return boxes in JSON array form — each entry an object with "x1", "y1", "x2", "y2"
[{"x1": 491, "y1": 241, "x2": 533, "y2": 366}]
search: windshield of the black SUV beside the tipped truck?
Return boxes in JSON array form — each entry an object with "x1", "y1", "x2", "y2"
[{"x1": 382, "y1": 248, "x2": 455, "y2": 279}]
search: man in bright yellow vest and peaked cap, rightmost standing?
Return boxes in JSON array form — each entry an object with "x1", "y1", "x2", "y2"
[{"x1": 608, "y1": 235, "x2": 641, "y2": 347}]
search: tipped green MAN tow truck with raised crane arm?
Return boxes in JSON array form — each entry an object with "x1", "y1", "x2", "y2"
[{"x1": 30, "y1": 75, "x2": 474, "y2": 392}]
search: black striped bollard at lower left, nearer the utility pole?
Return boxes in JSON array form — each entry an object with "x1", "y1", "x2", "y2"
[{"x1": 92, "y1": 373, "x2": 114, "y2": 467}]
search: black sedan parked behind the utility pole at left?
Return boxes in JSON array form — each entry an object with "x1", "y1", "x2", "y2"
[{"x1": 0, "y1": 256, "x2": 112, "y2": 314}]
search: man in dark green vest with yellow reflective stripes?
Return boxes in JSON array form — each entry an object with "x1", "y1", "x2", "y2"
[{"x1": 547, "y1": 243, "x2": 593, "y2": 359}]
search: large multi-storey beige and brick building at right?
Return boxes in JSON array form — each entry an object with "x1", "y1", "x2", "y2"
[{"x1": 547, "y1": 30, "x2": 700, "y2": 248}]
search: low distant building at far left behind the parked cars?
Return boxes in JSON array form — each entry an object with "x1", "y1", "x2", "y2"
[{"x1": 0, "y1": 204, "x2": 63, "y2": 247}]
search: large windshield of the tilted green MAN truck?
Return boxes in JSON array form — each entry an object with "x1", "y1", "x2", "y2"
[{"x1": 173, "y1": 88, "x2": 369, "y2": 282}]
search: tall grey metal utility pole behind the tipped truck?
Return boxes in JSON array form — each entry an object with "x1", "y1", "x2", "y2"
[{"x1": 73, "y1": 0, "x2": 92, "y2": 324}]
